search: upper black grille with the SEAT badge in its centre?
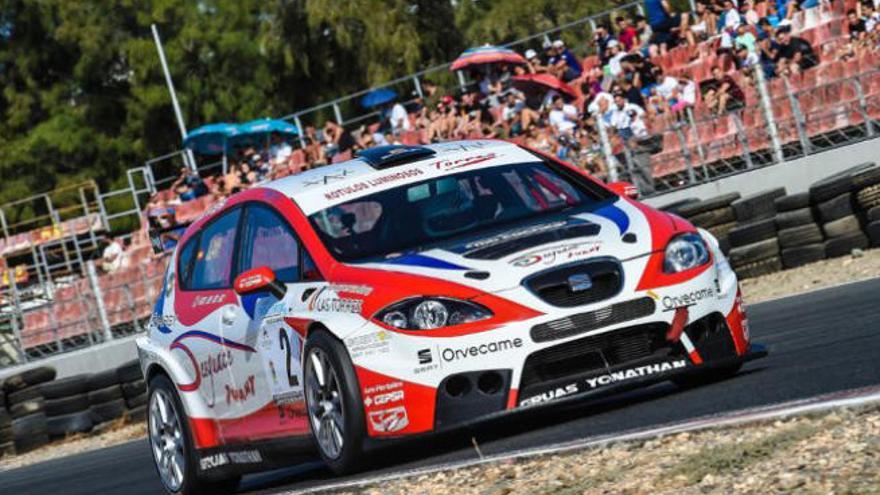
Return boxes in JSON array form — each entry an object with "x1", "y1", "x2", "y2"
[{"x1": 523, "y1": 259, "x2": 623, "y2": 308}]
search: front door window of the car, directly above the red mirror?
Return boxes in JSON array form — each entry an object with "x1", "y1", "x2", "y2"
[{"x1": 239, "y1": 203, "x2": 300, "y2": 283}]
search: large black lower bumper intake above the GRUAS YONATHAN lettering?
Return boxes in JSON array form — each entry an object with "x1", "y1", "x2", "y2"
[{"x1": 520, "y1": 323, "x2": 671, "y2": 389}]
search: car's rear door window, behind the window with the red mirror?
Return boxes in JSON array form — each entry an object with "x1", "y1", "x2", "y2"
[{"x1": 190, "y1": 208, "x2": 241, "y2": 290}]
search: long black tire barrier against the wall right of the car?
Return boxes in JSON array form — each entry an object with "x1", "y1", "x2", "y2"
[{"x1": 661, "y1": 163, "x2": 880, "y2": 279}]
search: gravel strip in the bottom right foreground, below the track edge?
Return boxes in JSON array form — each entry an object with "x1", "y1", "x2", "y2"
[{"x1": 334, "y1": 406, "x2": 880, "y2": 495}]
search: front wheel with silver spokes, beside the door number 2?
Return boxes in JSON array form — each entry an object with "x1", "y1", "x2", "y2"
[{"x1": 304, "y1": 330, "x2": 366, "y2": 474}]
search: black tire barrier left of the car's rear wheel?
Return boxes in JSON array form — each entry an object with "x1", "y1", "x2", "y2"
[{"x1": 0, "y1": 360, "x2": 147, "y2": 457}]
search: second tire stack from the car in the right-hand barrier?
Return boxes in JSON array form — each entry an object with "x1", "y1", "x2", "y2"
[{"x1": 728, "y1": 187, "x2": 785, "y2": 279}]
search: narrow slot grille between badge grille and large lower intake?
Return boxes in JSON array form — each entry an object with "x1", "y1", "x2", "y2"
[{"x1": 531, "y1": 297, "x2": 656, "y2": 342}]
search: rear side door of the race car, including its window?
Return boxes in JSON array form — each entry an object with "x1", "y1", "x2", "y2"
[{"x1": 172, "y1": 208, "x2": 255, "y2": 441}]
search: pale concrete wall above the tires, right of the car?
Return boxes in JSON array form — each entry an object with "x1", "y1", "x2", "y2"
[{"x1": 645, "y1": 138, "x2": 880, "y2": 206}]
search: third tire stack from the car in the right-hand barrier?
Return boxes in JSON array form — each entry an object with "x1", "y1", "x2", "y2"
[{"x1": 775, "y1": 193, "x2": 825, "y2": 268}]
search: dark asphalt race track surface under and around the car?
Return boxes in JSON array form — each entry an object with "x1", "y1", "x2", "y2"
[{"x1": 0, "y1": 279, "x2": 880, "y2": 495}]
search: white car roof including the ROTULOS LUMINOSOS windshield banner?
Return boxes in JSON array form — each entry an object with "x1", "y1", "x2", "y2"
[{"x1": 265, "y1": 140, "x2": 538, "y2": 215}]
